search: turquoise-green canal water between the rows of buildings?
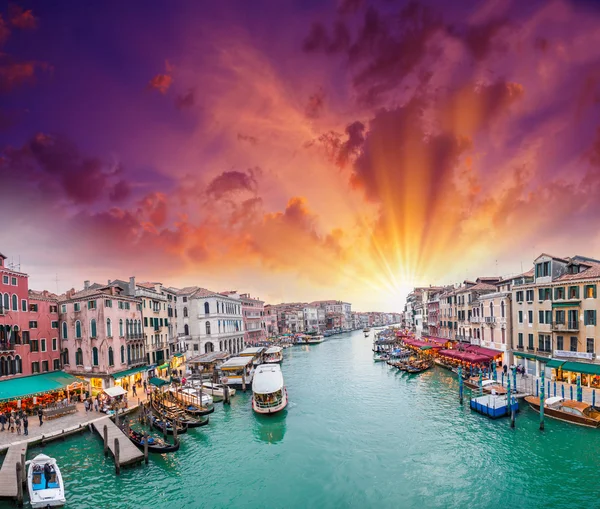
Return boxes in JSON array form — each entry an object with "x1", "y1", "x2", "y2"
[{"x1": 21, "y1": 331, "x2": 600, "y2": 509}]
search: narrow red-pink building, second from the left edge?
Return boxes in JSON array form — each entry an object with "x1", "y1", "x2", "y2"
[{"x1": 29, "y1": 290, "x2": 62, "y2": 374}]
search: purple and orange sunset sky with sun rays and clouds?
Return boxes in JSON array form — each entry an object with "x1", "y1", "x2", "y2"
[{"x1": 0, "y1": 0, "x2": 600, "y2": 311}]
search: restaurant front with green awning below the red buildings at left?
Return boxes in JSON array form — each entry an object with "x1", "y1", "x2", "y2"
[{"x1": 0, "y1": 371, "x2": 87, "y2": 415}]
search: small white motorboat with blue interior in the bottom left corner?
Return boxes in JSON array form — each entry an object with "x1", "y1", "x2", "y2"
[{"x1": 25, "y1": 454, "x2": 66, "y2": 508}]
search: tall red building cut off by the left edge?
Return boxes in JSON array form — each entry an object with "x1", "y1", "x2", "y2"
[{"x1": 0, "y1": 253, "x2": 31, "y2": 378}]
